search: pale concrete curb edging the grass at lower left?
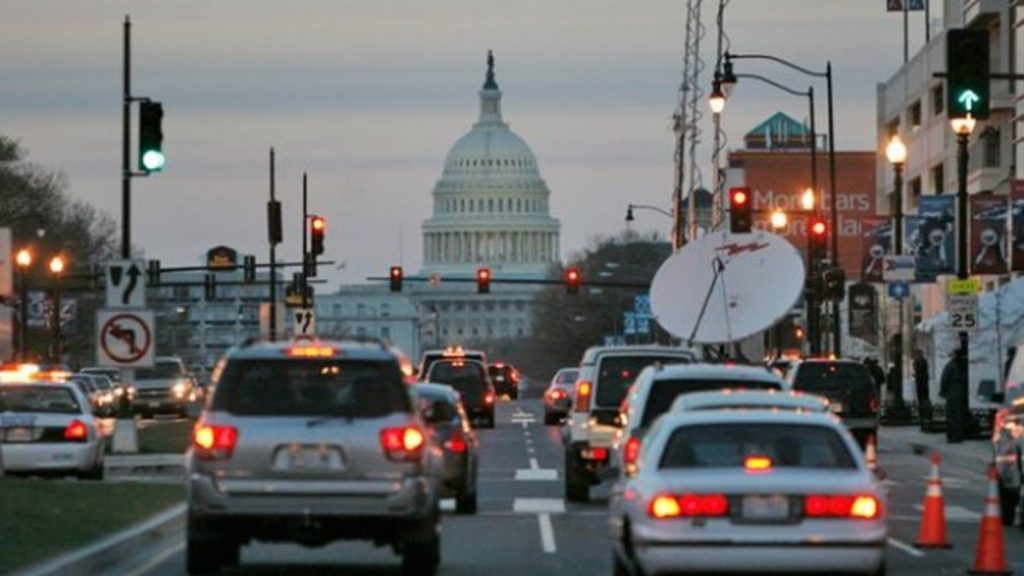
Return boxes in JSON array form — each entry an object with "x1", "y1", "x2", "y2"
[{"x1": 12, "y1": 503, "x2": 185, "y2": 576}]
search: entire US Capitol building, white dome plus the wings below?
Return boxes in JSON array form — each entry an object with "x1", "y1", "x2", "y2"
[{"x1": 316, "y1": 53, "x2": 560, "y2": 360}]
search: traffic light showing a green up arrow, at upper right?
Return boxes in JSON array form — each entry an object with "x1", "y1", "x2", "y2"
[{"x1": 946, "y1": 29, "x2": 988, "y2": 120}]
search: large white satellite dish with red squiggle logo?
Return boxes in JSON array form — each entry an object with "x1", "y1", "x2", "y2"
[{"x1": 650, "y1": 232, "x2": 804, "y2": 344}]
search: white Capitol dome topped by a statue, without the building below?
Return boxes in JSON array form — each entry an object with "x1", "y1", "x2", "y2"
[{"x1": 423, "y1": 53, "x2": 560, "y2": 278}]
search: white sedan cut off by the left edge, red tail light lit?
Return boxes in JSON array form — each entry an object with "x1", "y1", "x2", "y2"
[{"x1": 0, "y1": 382, "x2": 103, "y2": 480}]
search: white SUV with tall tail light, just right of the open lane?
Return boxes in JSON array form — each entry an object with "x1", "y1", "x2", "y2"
[{"x1": 564, "y1": 345, "x2": 696, "y2": 502}]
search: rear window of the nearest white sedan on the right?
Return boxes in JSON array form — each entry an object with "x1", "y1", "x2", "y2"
[{"x1": 658, "y1": 422, "x2": 857, "y2": 469}]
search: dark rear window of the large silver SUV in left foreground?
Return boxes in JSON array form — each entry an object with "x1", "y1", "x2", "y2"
[{"x1": 212, "y1": 360, "x2": 412, "y2": 418}]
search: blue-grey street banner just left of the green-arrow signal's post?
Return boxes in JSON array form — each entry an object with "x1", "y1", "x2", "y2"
[{"x1": 904, "y1": 196, "x2": 956, "y2": 282}]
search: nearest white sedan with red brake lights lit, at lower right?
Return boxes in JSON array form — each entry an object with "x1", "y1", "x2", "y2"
[{"x1": 609, "y1": 410, "x2": 887, "y2": 576}]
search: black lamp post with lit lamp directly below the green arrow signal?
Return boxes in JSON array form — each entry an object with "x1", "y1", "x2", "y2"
[{"x1": 946, "y1": 116, "x2": 976, "y2": 443}]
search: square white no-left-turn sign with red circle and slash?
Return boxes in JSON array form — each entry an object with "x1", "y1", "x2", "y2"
[{"x1": 96, "y1": 310, "x2": 156, "y2": 368}]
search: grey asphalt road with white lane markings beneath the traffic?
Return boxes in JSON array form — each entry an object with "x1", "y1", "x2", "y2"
[{"x1": 94, "y1": 385, "x2": 1024, "y2": 576}]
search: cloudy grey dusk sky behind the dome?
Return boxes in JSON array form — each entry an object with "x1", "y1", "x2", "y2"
[{"x1": 0, "y1": 0, "x2": 939, "y2": 285}]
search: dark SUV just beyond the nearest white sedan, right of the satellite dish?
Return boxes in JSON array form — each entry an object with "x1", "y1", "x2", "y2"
[{"x1": 786, "y1": 358, "x2": 879, "y2": 447}]
